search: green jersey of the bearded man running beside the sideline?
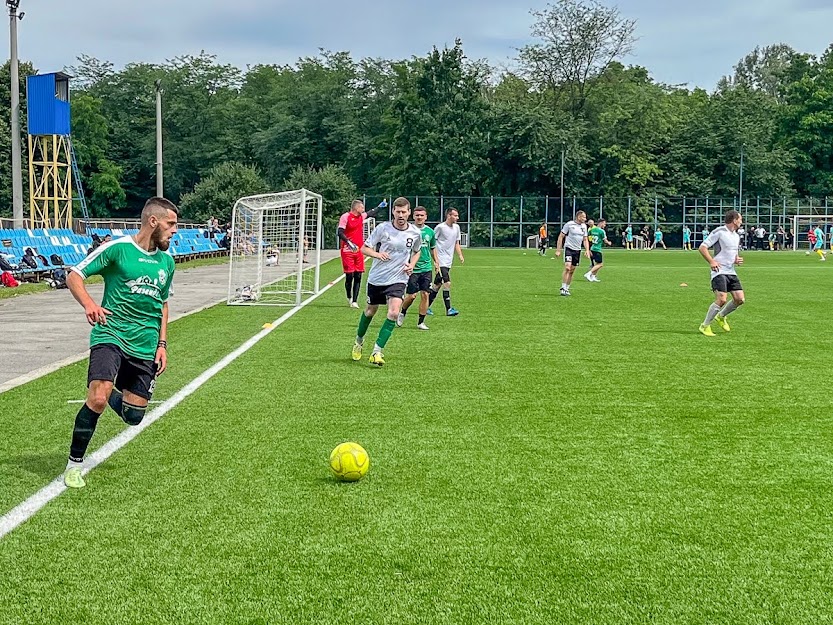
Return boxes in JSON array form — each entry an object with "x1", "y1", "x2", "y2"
[{"x1": 72, "y1": 236, "x2": 174, "y2": 360}]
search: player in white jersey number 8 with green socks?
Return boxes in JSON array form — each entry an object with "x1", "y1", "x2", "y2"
[{"x1": 352, "y1": 197, "x2": 422, "y2": 367}]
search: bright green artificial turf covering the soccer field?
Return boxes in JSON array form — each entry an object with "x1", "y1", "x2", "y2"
[{"x1": 0, "y1": 250, "x2": 833, "y2": 625}]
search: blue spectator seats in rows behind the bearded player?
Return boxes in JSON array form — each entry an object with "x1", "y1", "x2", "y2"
[{"x1": 0, "y1": 223, "x2": 225, "y2": 275}]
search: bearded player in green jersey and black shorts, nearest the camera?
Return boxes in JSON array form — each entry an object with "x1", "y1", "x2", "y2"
[{"x1": 64, "y1": 197, "x2": 177, "y2": 488}]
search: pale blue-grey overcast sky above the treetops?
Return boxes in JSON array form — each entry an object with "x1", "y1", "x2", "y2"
[{"x1": 6, "y1": 0, "x2": 833, "y2": 90}]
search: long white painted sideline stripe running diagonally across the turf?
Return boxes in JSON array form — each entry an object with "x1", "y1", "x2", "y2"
[{"x1": 0, "y1": 274, "x2": 344, "y2": 539}]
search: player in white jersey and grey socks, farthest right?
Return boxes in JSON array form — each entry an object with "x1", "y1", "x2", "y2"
[{"x1": 699, "y1": 210, "x2": 745, "y2": 336}]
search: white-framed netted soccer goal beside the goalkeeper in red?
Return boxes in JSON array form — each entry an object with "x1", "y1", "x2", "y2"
[{"x1": 227, "y1": 189, "x2": 322, "y2": 306}]
